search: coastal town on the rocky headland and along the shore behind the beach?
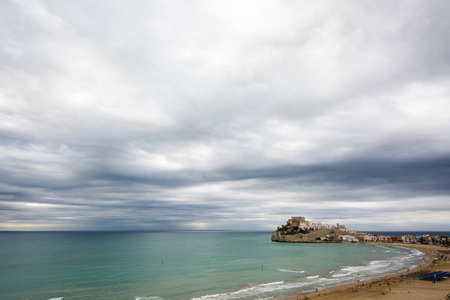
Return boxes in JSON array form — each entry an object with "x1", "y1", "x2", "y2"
[{"x1": 271, "y1": 217, "x2": 450, "y2": 247}]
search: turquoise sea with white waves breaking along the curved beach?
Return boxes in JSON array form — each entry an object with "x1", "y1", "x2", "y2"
[{"x1": 0, "y1": 232, "x2": 424, "y2": 300}]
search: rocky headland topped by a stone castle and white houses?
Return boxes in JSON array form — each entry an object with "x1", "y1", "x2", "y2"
[{"x1": 272, "y1": 217, "x2": 367, "y2": 243}]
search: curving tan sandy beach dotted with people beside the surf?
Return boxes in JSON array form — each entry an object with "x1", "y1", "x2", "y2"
[{"x1": 280, "y1": 243, "x2": 450, "y2": 300}]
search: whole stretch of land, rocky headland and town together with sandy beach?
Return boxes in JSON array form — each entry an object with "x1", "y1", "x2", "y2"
[{"x1": 272, "y1": 217, "x2": 450, "y2": 300}]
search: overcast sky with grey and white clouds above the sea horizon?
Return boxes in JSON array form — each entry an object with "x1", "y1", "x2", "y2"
[{"x1": 0, "y1": 0, "x2": 450, "y2": 231}]
